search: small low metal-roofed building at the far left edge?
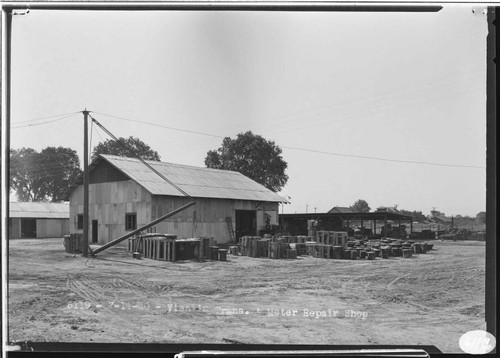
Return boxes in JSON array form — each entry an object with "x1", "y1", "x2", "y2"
[{"x1": 9, "y1": 202, "x2": 69, "y2": 239}]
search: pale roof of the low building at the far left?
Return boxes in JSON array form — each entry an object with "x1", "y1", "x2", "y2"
[{"x1": 9, "y1": 201, "x2": 69, "y2": 219}]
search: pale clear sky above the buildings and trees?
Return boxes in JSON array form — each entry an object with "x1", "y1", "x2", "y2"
[{"x1": 7, "y1": 5, "x2": 487, "y2": 216}]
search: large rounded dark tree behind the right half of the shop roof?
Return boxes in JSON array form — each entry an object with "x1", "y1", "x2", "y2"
[{"x1": 205, "y1": 131, "x2": 288, "y2": 192}]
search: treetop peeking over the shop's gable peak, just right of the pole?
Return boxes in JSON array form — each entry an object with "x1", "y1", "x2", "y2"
[{"x1": 91, "y1": 136, "x2": 160, "y2": 161}]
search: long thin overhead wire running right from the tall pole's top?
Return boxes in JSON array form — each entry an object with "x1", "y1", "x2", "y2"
[{"x1": 92, "y1": 112, "x2": 486, "y2": 169}]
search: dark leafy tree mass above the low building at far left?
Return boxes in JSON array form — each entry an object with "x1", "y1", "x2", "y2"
[{"x1": 10, "y1": 147, "x2": 81, "y2": 201}]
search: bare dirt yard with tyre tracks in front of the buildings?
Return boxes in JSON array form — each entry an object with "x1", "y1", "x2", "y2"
[{"x1": 9, "y1": 239, "x2": 486, "y2": 352}]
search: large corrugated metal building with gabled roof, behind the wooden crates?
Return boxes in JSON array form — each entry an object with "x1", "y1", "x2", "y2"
[{"x1": 67, "y1": 155, "x2": 286, "y2": 244}]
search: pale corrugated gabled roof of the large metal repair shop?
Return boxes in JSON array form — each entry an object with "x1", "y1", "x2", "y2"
[{"x1": 66, "y1": 155, "x2": 287, "y2": 202}]
